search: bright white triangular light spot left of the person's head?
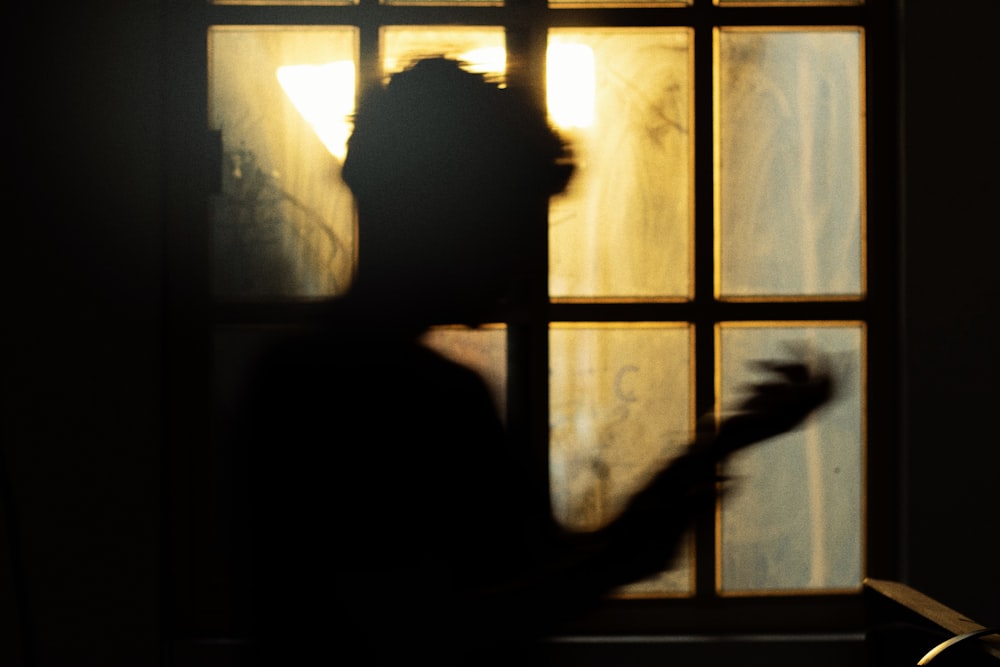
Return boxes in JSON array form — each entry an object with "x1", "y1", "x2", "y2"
[{"x1": 277, "y1": 61, "x2": 355, "y2": 160}]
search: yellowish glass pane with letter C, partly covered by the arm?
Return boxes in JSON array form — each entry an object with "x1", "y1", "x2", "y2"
[{"x1": 549, "y1": 324, "x2": 693, "y2": 593}]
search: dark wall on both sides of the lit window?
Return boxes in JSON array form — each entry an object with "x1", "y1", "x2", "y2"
[{"x1": 0, "y1": 0, "x2": 1000, "y2": 667}]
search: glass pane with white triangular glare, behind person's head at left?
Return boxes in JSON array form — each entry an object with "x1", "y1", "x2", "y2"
[{"x1": 209, "y1": 28, "x2": 357, "y2": 297}]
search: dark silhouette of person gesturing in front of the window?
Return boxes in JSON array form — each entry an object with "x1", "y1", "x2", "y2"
[{"x1": 240, "y1": 58, "x2": 831, "y2": 665}]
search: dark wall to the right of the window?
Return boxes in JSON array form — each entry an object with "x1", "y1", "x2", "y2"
[{"x1": 902, "y1": 0, "x2": 1000, "y2": 625}]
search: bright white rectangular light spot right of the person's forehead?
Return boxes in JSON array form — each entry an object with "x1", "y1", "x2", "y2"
[{"x1": 546, "y1": 43, "x2": 595, "y2": 129}]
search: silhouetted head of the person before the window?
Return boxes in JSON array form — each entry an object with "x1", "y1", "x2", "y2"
[{"x1": 343, "y1": 58, "x2": 572, "y2": 324}]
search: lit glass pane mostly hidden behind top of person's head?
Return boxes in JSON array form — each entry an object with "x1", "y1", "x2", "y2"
[{"x1": 382, "y1": 26, "x2": 507, "y2": 80}]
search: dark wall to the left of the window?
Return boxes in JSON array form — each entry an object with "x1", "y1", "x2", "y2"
[{"x1": 0, "y1": 0, "x2": 162, "y2": 667}]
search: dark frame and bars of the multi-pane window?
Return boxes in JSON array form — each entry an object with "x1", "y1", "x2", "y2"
[{"x1": 162, "y1": 0, "x2": 901, "y2": 638}]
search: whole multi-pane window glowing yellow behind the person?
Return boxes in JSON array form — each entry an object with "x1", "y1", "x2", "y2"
[{"x1": 162, "y1": 0, "x2": 895, "y2": 630}]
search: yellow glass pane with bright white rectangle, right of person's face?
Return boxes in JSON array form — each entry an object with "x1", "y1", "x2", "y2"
[{"x1": 547, "y1": 28, "x2": 692, "y2": 298}]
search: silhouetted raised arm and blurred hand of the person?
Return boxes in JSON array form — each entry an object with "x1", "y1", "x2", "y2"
[{"x1": 472, "y1": 363, "x2": 833, "y2": 636}]
